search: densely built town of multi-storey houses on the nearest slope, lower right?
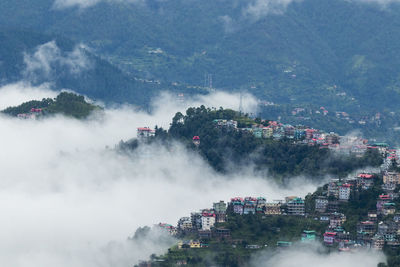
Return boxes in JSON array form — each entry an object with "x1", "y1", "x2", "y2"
[{"x1": 143, "y1": 144, "x2": 400, "y2": 266}]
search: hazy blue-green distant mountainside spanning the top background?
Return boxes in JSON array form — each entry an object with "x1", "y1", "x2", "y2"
[{"x1": 0, "y1": 0, "x2": 400, "y2": 111}]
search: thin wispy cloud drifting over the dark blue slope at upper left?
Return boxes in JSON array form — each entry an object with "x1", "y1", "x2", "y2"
[{"x1": 23, "y1": 41, "x2": 91, "y2": 81}]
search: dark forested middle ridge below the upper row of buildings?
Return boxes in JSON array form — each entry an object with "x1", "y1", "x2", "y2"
[{"x1": 118, "y1": 106, "x2": 382, "y2": 183}]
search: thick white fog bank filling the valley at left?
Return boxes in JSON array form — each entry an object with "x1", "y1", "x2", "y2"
[{"x1": 0, "y1": 84, "x2": 317, "y2": 267}]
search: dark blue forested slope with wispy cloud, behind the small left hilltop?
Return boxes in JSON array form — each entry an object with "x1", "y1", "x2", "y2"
[{"x1": 0, "y1": 29, "x2": 192, "y2": 104}]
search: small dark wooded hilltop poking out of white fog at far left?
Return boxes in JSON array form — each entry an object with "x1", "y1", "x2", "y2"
[{"x1": 2, "y1": 92, "x2": 101, "y2": 119}]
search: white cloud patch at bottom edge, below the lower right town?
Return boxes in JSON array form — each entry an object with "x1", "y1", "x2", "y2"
[{"x1": 251, "y1": 243, "x2": 386, "y2": 267}]
